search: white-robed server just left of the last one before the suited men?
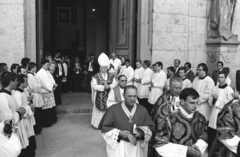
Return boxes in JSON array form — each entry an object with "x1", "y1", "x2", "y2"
[{"x1": 138, "y1": 60, "x2": 153, "y2": 111}]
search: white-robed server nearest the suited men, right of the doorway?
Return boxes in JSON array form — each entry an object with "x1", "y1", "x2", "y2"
[{"x1": 147, "y1": 62, "x2": 167, "y2": 114}]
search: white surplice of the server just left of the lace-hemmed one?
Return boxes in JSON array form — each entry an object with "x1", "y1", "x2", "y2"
[{"x1": 28, "y1": 74, "x2": 44, "y2": 108}]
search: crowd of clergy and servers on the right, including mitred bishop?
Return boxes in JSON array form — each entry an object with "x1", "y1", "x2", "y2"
[{"x1": 90, "y1": 53, "x2": 240, "y2": 157}]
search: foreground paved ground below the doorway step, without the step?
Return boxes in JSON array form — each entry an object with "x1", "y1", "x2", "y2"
[{"x1": 36, "y1": 113, "x2": 107, "y2": 157}]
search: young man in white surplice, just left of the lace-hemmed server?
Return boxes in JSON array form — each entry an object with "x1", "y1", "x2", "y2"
[{"x1": 27, "y1": 62, "x2": 44, "y2": 134}]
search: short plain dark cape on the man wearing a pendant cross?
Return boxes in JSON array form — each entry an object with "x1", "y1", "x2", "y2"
[{"x1": 99, "y1": 103, "x2": 154, "y2": 133}]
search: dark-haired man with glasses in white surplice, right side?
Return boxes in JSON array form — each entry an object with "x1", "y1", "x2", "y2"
[{"x1": 193, "y1": 63, "x2": 214, "y2": 121}]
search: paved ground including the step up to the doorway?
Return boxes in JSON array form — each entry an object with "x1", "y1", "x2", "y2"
[{"x1": 36, "y1": 93, "x2": 107, "y2": 157}]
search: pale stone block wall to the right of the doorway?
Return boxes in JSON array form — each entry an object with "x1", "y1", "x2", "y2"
[{"x1": 152, "y1": 0, "x2": 240, "y2": 87}]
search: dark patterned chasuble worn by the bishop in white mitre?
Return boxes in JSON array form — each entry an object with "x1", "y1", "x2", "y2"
[{"x1": 93, "y1": 72, "x2": 114, "y2": 111}]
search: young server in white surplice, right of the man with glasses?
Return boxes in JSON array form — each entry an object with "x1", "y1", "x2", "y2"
[{"x1": 208, "y1": 70, "x2": 234, "y2": 145}]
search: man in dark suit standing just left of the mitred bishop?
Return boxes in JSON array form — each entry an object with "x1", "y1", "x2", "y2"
[{"x1": 87, "y1": 54, "x2": 99, "y2": 92}]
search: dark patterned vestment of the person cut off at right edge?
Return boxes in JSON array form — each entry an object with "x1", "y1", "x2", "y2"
[{"x1": 209, "y1": 100, "x2": 240, "y2": 157}]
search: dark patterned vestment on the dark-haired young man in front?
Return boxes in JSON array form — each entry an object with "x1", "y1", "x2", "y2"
[{"x1": 154, "y1": 109, "x2": 207, "y2": 157}]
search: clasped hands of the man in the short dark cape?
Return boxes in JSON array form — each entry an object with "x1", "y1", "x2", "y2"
[{"x1": 119, "y1": 129, "x2": 144, "y2": 146}]
